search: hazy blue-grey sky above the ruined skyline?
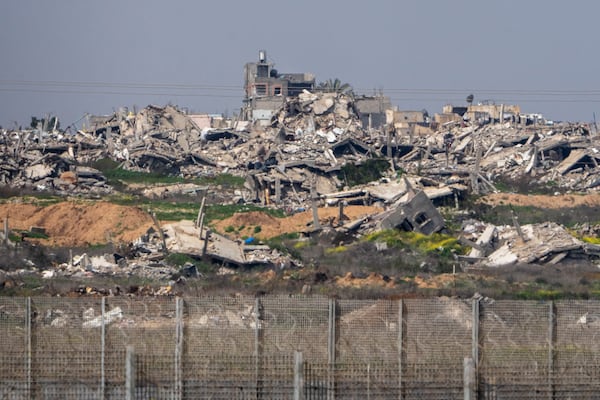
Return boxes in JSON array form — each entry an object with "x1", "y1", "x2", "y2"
[{"x1": 0, "y1": 0, "x2": 600, "y2": 128}]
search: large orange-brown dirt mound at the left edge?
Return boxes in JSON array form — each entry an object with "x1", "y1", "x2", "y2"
[{"x1": 0, "y1": 202, "x2": 152, "y2": 247}]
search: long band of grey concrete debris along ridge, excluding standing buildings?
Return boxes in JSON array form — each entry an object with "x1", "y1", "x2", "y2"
[{"x1": 0, "y1": 101, "x2": 600, "y2": 209}]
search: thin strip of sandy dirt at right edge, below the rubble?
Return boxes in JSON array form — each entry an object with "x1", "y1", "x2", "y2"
[{"x1": 479, "y1": 193, "x2": 600, "y2": 209}]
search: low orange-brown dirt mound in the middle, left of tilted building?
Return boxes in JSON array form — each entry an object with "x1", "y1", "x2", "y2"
[{"x1": 213, "y1": 206, "x2": 382, "y2": 239}]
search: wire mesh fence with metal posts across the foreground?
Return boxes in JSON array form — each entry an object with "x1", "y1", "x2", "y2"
[{"x1": 0, "y1": 296, "x2": 600, "y2": 399}]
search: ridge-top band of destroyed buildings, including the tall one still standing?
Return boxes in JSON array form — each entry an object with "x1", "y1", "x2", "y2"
[{"x1": 0, "y1": 51, "x2": 600, "y2": 272}]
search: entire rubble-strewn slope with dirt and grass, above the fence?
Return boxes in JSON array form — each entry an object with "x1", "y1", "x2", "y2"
[{"x1": 0, "y1": 92, "x2": 600, "y2": 298}]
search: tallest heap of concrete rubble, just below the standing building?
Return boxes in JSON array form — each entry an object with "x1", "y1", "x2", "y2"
[{"x1": 246, "y1": 90, "x2": 379, "y2": 209}]
